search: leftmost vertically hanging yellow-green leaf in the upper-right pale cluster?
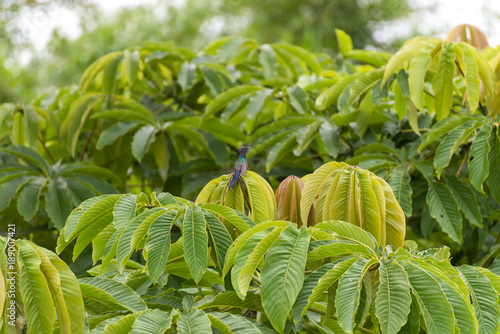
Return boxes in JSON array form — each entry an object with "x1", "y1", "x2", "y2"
[{"x1": 408, "y1": 43, "x2": 439, "y2": 110}]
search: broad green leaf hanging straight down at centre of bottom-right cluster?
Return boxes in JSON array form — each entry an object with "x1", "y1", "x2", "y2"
[{"x1": 375, "y1": 260, "x2": 411, "y2": 334}]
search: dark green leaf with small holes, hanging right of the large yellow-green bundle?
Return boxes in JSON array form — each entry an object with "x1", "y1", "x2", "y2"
[{"x1": 427, "y1": 179, "x2": 462, "y2": 244}]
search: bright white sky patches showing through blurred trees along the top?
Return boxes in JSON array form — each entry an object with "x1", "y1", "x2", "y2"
[{"x1": 8, "y1": 0, "x2": 500, "y2": 56}]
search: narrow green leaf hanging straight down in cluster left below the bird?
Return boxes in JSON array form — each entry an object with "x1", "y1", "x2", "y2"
[{"x1": 182, "y1": 205, "x2": 208, "y2": 283}]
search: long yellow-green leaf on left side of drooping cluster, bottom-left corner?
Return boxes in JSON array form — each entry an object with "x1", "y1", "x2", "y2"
[{"x1": 17, "y1": 244, "x2": 56, "y2": 334}]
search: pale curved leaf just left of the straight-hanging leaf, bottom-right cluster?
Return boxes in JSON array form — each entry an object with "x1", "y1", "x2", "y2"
[{"x1": 335, "y1": 258, "x2": 377, "y2": 333}]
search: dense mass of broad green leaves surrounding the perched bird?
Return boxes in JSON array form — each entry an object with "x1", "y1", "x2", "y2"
[{"x1": 0, "y1": 26, "x2": 500, "y2": 333}]
